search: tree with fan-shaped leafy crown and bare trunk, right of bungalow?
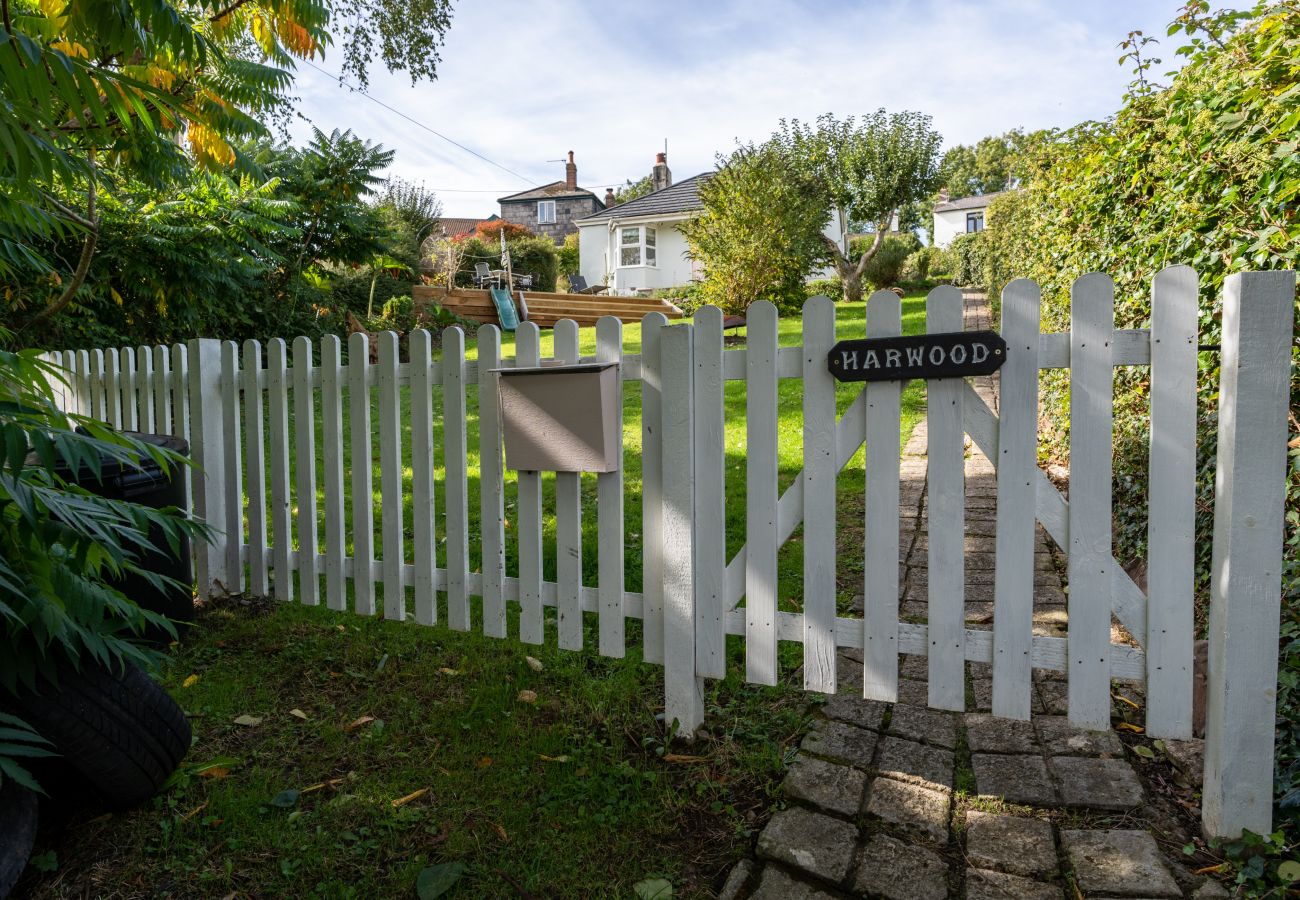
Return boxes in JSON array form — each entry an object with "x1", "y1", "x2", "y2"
[{"x1": 772, "y1": 109, "x2": 943, "y2": 302}]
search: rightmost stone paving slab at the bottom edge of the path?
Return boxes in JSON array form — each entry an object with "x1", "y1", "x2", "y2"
[{"x1": 1061, "y1": 830, "x2": 1183, "y2": 897}]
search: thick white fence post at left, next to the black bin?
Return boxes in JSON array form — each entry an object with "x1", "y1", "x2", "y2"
[{"x1": 186, "y1": 338, "x2": 230, "y2": 597}]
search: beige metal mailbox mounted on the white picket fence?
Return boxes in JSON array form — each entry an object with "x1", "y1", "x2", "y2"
[{"x1": 493, "y1": 363, "x2": 623, "y2": 472}]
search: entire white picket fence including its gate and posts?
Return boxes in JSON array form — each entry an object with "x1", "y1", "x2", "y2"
[{"x1": 40, "y1": 267, "x2": 1295, "y2": 835}]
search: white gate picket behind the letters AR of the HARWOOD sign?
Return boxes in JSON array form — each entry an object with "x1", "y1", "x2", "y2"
[{"x1": 862, "y1": 290, "x2": 902, "y2": 702}]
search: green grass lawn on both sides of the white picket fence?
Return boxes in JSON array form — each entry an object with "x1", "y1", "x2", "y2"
[{"x1": 25, "y1": 295, "x2": 924, "y2": 899}]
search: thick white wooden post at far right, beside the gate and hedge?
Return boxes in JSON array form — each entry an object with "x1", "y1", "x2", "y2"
[{"x1": 1201, "y1": 272, "x2": 1295, "y2": 838}]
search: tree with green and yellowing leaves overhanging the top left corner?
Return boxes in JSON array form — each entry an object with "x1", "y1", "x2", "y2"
[{"x1": 0, "y1": 0, "x2": 450, "y2": 338}]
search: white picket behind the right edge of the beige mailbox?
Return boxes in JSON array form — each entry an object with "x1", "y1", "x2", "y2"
[{"x1": 595, "y1": 316, "x2": 627, "y2": 659}]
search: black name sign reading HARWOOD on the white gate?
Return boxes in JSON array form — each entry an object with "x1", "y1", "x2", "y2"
[{"x1": 827, "y1": 332, "x2": 1006, "y2": 381}]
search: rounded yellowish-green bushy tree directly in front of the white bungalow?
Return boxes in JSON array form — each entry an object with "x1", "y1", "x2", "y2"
[{"x1": 679, "y1": 140, "x2": 829, "y2": 313}]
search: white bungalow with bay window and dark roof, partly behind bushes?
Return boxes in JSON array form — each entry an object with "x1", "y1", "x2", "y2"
[{"x1": 577, "y1": 153, "x2": 848, "y2": 294}]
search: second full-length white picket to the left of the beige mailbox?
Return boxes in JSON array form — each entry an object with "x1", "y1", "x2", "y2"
[{"x1": 442, "y1": 326, "x2": 469, "y2": 631}]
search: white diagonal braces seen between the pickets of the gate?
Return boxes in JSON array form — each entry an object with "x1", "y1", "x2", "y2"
[{"x1": 727, "y1": 381, "x2": 1147, "y2": 646}]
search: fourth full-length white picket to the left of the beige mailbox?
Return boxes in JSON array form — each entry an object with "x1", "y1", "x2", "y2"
[{"x1": 376, "y1": 332, "x2": 406, "y2": 622}]
